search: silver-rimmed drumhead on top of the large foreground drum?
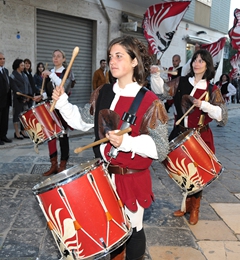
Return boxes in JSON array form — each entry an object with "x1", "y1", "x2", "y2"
[{"x1": 32, "y1": 158, "x2": 102, "y2": 195}]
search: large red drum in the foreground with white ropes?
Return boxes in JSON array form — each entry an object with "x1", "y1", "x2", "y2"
[{"x1": 33, "y1": 159, "x2": 132, "y2": 260}]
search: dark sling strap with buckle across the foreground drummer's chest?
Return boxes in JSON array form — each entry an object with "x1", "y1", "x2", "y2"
[{"x1": 109, "y1": 87, "x2": 148, "y2": 159}]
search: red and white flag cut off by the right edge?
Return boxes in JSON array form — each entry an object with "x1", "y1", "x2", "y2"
[{"x1": 228, "y1": 8, "x2": 240, "y2": 51}]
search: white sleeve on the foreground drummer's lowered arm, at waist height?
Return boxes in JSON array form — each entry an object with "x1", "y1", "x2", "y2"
[{"x1": 118, "y1": 134, "x2": 158, "y2": 159}]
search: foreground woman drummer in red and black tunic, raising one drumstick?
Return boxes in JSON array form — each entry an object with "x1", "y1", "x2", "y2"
[{"x1": 53, "y1": 36, "x2": 168, "y2": 260}]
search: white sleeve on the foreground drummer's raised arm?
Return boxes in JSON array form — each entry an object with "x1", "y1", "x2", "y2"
[{"x1": 55, "y1": 93, "x2": 94, "y2": 132}]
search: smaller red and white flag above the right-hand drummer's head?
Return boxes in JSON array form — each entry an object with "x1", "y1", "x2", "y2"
[{"x1": 201, "y1": 37, "x2": 227, "y2": 70}]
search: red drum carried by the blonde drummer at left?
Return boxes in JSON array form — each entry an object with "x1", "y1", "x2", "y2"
[{"x1": 19, "y1": 102, "x2": 64, "y2": 144}]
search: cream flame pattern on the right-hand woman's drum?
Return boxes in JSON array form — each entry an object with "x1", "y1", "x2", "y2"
[{"x1": 166, "y1": 157, "x2": 204, "y2": 192}]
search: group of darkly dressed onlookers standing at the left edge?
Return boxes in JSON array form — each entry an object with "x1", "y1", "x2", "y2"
[{"x1": 0, "y1": 52, "x2": 44, "y2": 145}]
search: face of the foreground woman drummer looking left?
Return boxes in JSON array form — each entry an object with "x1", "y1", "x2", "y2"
[{"x1": 109, "y1": 44, "x2": 137, "y2": 84}]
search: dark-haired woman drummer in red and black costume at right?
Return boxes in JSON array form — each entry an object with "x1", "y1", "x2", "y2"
[{"x1": 151, "y1": 49, "x2": 227, "y2": 225}]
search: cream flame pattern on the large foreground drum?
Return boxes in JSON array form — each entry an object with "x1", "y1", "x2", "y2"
[{"x1": 48, "y1": 204, "x2": 83, "y2": 260}]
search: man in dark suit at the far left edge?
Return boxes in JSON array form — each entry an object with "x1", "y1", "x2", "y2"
[{"x1": 0, "y1": 52, "x2": 12, "y2": 145}]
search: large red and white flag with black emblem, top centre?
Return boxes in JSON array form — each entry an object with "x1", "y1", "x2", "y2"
[{"x1": 143, "y1": 1, "x2": 191, "y2": 54}]
